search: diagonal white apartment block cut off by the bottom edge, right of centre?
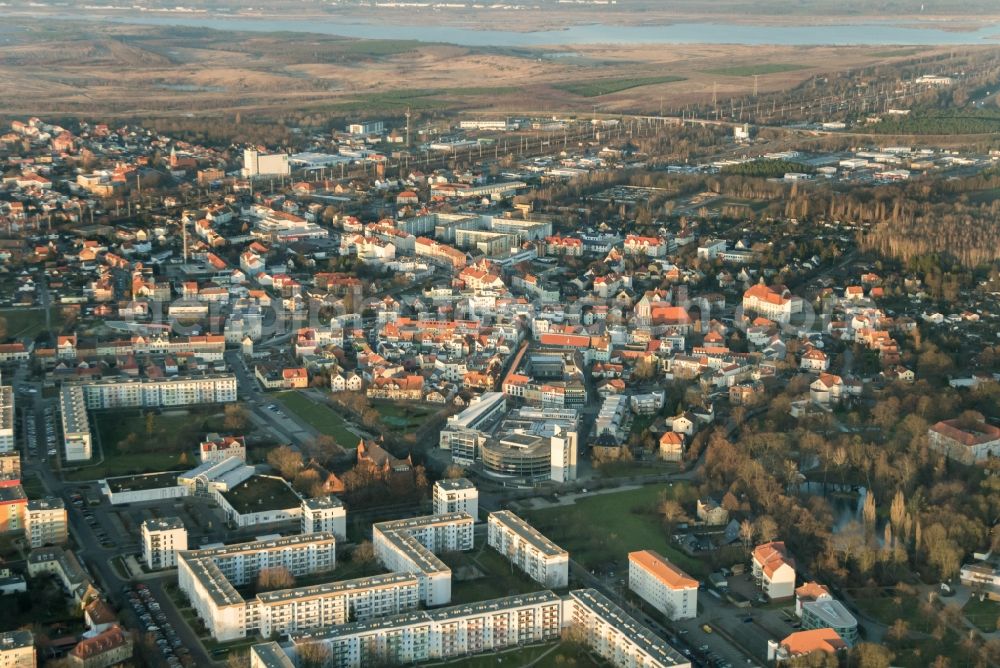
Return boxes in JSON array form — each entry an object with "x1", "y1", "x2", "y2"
[{"x1": 562, "y1": 589, "x2": 691, "y2": 668}]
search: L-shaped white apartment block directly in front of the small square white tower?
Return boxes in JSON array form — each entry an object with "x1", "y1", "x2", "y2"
[{"x1": 372, "y1": 513, "x2": 475, "y2": 605}]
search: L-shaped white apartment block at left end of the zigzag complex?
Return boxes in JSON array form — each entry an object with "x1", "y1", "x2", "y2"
[{"x1": 177, "y1": 533, "x2": 337, "y2": 641}]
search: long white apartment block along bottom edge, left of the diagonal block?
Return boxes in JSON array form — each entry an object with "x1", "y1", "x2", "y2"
[{"x1": 279, "y1": 591, "x2": 562, "y2": 668}]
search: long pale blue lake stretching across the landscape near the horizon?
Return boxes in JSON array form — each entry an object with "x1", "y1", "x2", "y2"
[{"x1": 17, "y1": 11, "x2": 1000, "y2": 47}]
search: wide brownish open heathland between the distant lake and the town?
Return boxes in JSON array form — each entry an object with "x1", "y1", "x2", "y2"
[{"x1": 0, "y1": 14, "x2": 960, "y2": 122}]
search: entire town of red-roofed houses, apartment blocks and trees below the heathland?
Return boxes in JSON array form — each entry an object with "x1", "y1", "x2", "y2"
[{"x1": 0, "y1": 90, "x2": 1000, "y2": 668}]
